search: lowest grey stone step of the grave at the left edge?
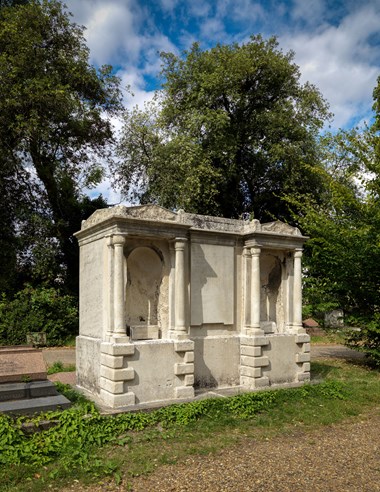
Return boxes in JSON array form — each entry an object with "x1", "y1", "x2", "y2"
[{"x1": 0, "y1": 395, "x2": 71, "y2": 415}]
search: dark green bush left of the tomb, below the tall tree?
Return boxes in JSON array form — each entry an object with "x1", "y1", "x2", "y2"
[{"x1": 0, "y1": 285, "x2": 78, "y2": 346}]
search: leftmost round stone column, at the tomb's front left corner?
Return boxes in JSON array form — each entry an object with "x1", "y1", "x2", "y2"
[{"x1": 113, "y1": 235, "x2": 126, "y2": 338}]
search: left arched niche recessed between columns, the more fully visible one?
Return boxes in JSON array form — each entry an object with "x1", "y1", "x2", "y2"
[{"x1": 126, "y1": 246, "x2": 163, "y2": 339}]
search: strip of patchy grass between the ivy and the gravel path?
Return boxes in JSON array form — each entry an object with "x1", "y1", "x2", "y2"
[{"x1": 0, "y1": 359, "x2": 380, "y2": 492}]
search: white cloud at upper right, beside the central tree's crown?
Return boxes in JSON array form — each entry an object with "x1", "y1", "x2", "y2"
[{"x1": 280, "y1": 2, "x2": 380, "y2": 128}]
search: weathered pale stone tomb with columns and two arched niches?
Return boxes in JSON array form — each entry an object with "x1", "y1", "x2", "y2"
[{"x1": 76, "y1": 205, "x2": 310, "y2": 408}]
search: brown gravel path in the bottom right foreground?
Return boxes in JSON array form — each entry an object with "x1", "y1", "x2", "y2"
[{"x1": 130, "y1": 408, "x2": 380, "y2": 492}]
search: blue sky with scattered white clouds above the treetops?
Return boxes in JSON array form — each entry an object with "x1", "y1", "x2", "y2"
[{"x1": 65, "y1": 0, "x2": 380, "y2": 201}]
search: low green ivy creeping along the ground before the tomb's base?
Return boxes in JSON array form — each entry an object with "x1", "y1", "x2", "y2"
[{"x1": 0, "y1": 381, "x2": 345, "y2": 472}]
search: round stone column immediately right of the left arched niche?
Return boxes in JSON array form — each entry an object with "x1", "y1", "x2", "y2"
[{"x1": 174, "y1": 238, "x2": 187, "y2": 335}]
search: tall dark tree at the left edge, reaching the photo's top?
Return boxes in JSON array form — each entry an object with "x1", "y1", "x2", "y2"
[{"x1": 0, "y1": 0, "x2": 121, "y2": 290}]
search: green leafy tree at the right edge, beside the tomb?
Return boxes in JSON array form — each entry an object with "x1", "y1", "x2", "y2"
[{"x1": 288, "y1": 127, "x2": 380, "y2": 364}]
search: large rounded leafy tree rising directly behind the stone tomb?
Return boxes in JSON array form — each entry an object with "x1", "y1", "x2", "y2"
[{"x1": 115, "y1": 36, "x2": 328, "y2": 219}]
